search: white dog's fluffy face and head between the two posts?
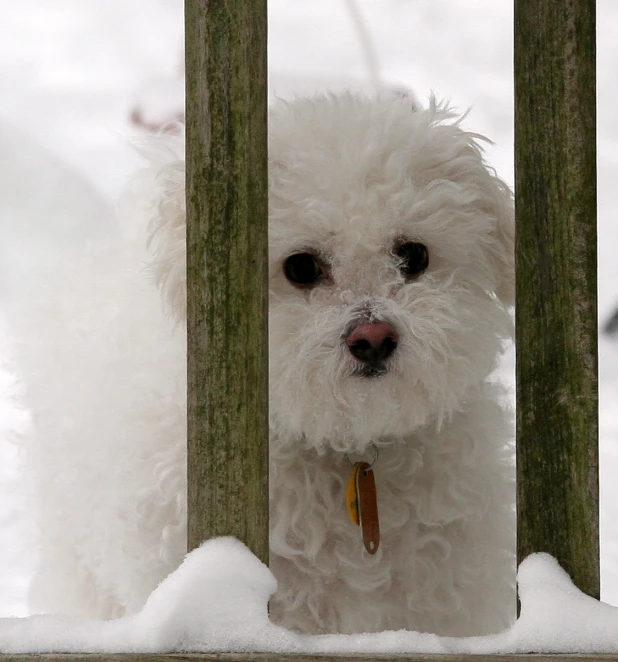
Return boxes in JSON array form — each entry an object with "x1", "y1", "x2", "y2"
[{"x1": 269, "y1": 96, "x2": 513, "y2": 451}]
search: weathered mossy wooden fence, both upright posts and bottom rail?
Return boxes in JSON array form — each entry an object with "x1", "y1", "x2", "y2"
[{"x1": 4, "y1": 0, "x2": 609, "y2": 662}]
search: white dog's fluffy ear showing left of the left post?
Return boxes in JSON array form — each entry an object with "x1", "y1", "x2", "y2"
[{"x1": 132, "y1": 132, "x2": 187, "y2": 324}]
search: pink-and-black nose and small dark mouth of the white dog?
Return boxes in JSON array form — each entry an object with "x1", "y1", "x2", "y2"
[{"x1": 344, "y1": 321, "x2": 399, "y2": 377}]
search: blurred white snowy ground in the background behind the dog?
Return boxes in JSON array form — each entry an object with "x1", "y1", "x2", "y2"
[{"x1": 0, "y1": 0, "x2": 618, "y2": 615}]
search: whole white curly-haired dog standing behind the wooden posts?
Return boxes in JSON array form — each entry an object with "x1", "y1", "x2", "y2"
[{"x1": 10, "y1": 95, "x2": 515, "y2": 635}]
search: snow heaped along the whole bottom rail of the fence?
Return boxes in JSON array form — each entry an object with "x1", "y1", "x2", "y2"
[{"x1": 0, "y1": 538, "x2": 618, "y2": 654}]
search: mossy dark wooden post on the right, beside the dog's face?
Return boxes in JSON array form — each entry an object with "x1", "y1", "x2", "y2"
[{"x1": 515, "y1": 0, "x2": 599, "y2": 597}]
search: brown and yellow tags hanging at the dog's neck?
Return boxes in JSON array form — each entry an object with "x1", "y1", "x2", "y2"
[{"x1": 346, "y1": 462, "x2": 380, "y2": 554}]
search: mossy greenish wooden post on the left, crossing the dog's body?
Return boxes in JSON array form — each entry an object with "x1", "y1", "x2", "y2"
[{"x1": 185, "y1": 0, "x2": 268, "y2": 562}]
